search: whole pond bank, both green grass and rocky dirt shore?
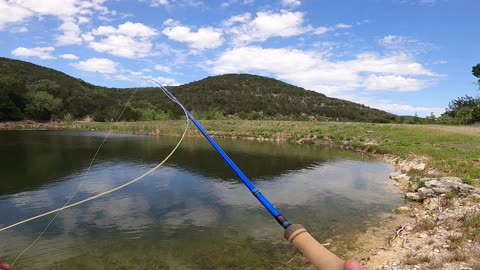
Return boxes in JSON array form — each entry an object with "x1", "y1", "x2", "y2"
[{"x1": 0, "y1": 120, "x2": 480, "y2": 269}]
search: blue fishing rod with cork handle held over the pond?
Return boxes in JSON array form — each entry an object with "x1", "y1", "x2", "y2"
[{"x1": 153, "y1": 81, "x2": 344, "y2": 270}]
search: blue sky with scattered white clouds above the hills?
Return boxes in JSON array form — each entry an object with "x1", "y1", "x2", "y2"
[{"x1": 0, "y1": 0, "x2": 480, "y2": 116}]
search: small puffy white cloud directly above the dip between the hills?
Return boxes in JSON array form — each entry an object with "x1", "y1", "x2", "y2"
[{"x1": 162, "y1": 25, "x2": 223, "y2": 50}]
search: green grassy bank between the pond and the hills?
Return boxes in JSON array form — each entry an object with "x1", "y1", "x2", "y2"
[{"x1": 0, "y1": 120, "x2": 480, "y2": 185}]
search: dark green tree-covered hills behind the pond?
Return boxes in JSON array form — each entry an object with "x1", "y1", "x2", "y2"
[{"x1": 0, "y1": 58, "x2": 398, "y2": 122}]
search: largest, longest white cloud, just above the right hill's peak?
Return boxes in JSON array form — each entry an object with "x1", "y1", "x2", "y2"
[{"x1": 208, "y1": 47, "x2": 436, "y2": 94}]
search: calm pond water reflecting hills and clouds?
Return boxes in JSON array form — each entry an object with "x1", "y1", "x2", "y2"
[{"x1": 0, "y1": 131, "x2": 402, "y2": 270}]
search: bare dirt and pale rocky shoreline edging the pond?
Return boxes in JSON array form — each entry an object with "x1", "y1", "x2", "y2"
[{"x1": 0, "y1": 121, "x2": 480, "y2": 270}]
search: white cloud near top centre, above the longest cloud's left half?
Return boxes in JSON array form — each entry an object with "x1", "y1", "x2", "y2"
[{"x1": 226, "y1": 10, "x2": 313, "y2": 45}]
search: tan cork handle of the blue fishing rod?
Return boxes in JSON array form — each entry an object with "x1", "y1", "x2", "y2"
[{"x1": 284, "y1": 224, "x2": 345, "y2": 270}]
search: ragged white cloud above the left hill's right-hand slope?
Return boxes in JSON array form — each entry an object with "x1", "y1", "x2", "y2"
[{"x1": 88, "y1": 22, "x2": 158, "y2": 58}]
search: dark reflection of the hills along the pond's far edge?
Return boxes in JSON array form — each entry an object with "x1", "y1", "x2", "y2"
[{"x1": 0, "y1": 131, "x2": 348, "y2": 195}]
